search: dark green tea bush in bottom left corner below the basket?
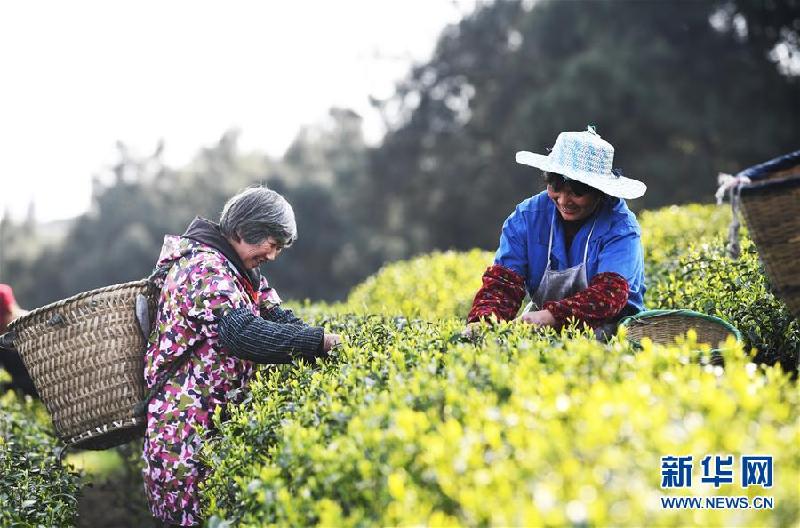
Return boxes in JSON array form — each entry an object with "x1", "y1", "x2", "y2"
[{"x1": 0, "y1": 371, "x2": 80, "y2": 527}]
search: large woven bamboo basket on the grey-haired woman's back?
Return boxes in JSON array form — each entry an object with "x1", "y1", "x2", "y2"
[{"x1": 10, "y1": 280, "x2": 158, "y2": 449}]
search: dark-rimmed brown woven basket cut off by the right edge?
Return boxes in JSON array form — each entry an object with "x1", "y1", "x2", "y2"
[{"x1": 739, "y1": 151, "x2": 800, "y2": 317}]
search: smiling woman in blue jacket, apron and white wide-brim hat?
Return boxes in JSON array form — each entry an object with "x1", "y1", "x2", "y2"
[{"x1": 467, "y1": 127, "x2": 646, "y2": 331}]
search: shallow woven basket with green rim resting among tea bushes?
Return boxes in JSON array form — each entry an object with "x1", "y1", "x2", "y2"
[{"x1": 620, "y1": 310, "x2": 742, "y2": 349}]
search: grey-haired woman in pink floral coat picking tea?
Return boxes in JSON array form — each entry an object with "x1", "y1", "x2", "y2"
[{"x1": 143, "y1": 187, "x2": 339, "y2": 526}]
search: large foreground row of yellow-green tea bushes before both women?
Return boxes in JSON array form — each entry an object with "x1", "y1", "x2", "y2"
[{"x1": 203, "y1": 317, "x2": 800, "y2": 526}]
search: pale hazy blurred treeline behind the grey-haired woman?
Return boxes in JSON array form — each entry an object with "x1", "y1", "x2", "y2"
[{"x1": 0, "y1": 114, "x2": 375, "y2": 307}]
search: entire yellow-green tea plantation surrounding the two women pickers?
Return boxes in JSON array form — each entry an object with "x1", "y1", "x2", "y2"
[{"x1": 0, "y1": 205, "x2": 800, "y2": 526}]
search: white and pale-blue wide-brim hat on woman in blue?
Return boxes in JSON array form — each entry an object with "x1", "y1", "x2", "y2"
[{"x1": 517, "y1": 126, "x2": 647, "y2": 200}]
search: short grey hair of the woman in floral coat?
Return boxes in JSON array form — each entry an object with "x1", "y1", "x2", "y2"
[{"x1": 219, "y1": 187, "x2": 297, "y2": 247}]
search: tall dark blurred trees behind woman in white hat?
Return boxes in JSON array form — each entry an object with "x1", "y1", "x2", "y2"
[{"x1": 369, "y1": 1, "x2": 800, "y2": 256}]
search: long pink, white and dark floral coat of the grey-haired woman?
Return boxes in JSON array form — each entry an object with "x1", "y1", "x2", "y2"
[{"x1": 143, "y1": 230, "x2": 296, "y2": 526}]
